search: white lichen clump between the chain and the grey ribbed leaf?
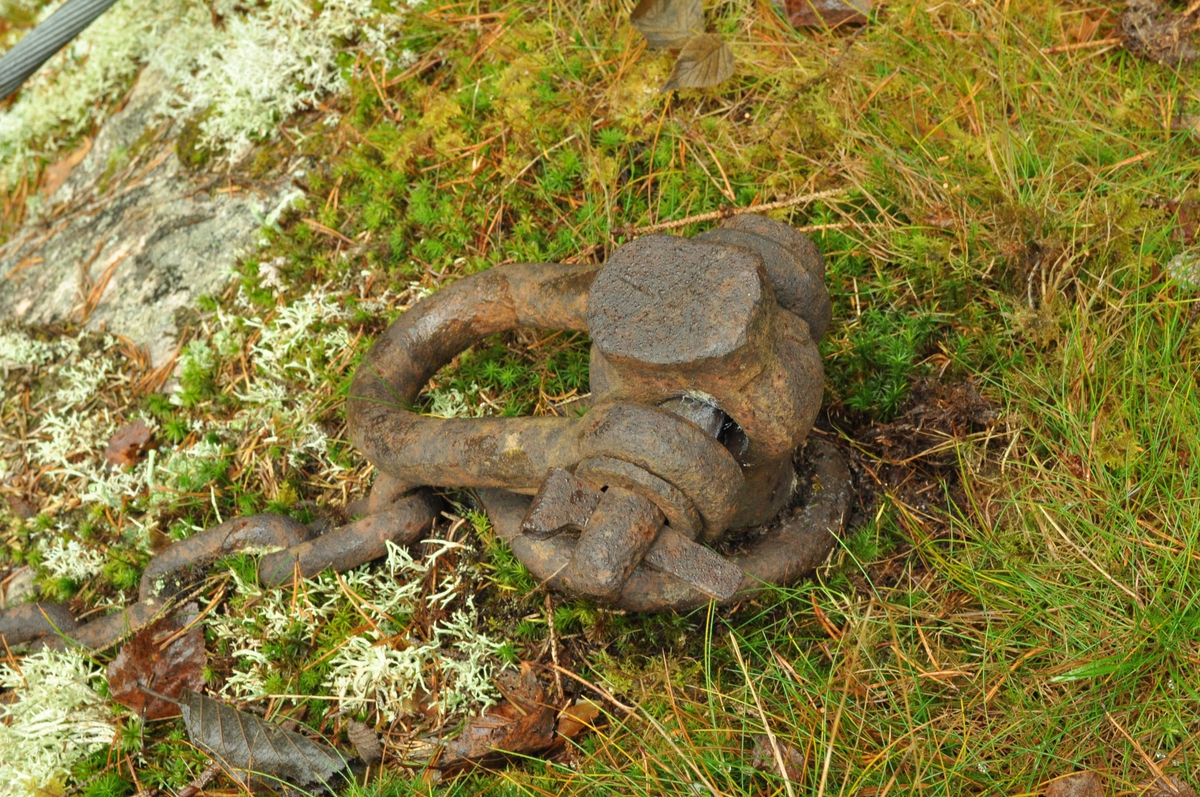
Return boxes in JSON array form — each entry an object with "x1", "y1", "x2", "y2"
[{"x1": 210, "y1": 540, "x2": 502, "y2": 721}]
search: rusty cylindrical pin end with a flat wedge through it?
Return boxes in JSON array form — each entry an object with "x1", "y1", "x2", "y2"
[{"x1": 564, "y1": 487, "x2": 664, "y2": 599}]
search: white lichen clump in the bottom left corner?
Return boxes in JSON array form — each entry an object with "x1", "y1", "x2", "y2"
[{"x1": 0, "y1": 651, "x2": 116, "y2": 797}]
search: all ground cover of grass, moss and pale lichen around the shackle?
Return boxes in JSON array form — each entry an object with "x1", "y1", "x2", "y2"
[{"x1": 0, "y1": 0, "x2": 1200, "y2": 797}]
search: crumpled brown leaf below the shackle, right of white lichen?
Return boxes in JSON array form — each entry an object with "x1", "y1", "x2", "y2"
[{"x1": 433, "y1": 664, "x2": 556, "y2": 769}]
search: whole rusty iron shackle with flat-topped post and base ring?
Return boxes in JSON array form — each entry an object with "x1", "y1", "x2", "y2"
[{"x1": 347, "y1": 215, "x2": 850, "y2": 611}]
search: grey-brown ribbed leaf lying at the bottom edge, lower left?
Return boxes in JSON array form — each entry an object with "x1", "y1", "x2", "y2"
[{"x1": 179, "y1": 689, "x2": 349, "y2": 792}]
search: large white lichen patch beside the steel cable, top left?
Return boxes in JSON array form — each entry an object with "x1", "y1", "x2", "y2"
[{"x1": 0, "y1": 0, "x2": 422, "y2": 185}]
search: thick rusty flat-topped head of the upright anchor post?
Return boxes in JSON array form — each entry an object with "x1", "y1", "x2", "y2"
[{"x1": 588, "y1": 230, "x2": 824, "y2": 470}]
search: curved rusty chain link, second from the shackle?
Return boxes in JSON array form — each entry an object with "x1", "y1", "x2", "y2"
[{"x1": 138, "y1": 514, "x2": 312, "y2": 600}]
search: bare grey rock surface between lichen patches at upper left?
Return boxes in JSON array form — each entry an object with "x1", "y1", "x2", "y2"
[{"x1": 0, "y1": 70, "x2": 298, "y2": 365}]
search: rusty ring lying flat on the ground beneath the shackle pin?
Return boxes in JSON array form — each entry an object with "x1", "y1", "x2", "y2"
[{"x1": 480, "y1": 439, "x2": 851, "y2": 611}]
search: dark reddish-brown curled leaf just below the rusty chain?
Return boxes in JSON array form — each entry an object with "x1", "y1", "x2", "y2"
[{"x1": 108, "y1": 604, "x2": 208, "y2": 720}]
